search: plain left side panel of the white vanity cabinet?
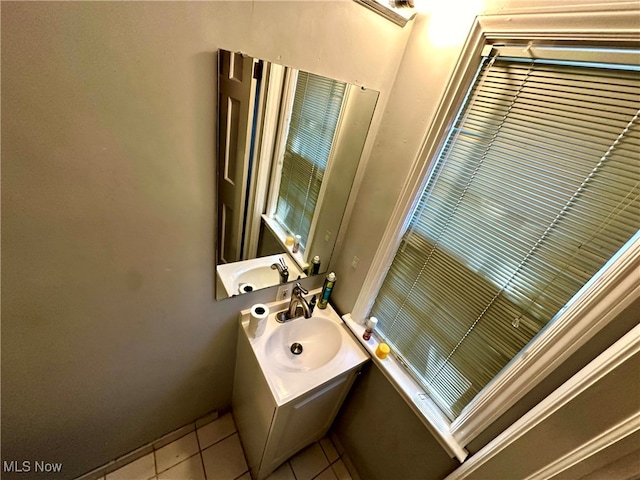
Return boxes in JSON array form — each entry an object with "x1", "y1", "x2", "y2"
[{"x1": 232, "y1": 325, "x2": 276, "y2": 478}]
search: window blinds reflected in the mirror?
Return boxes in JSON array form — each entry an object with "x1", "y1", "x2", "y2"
[{"x1": 275, "y1": 72, "x2": 346, "y2": 248}]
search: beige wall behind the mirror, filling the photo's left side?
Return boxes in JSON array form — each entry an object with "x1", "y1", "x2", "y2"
[{"x1": 1, "y1": 1, "x2": 409, "y2": 478}]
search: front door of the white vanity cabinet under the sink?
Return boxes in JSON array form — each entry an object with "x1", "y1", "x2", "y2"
[{"x1": 260, "y1": 372, "x2": 355, "y2": 477}]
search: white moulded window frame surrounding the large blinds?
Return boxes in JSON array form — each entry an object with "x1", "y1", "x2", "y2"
[{"x1": 345, "y1": 6, "x2": 640, "y2": 462}]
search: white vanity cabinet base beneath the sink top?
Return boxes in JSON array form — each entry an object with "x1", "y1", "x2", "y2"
[{"x1": 233, "y1": 325, "x2": 360, "y2": 480}]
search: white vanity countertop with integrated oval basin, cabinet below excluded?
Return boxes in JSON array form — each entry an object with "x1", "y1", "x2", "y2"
[{"x1": 240, "y1": 296, "x2": 369, "y2": 405}]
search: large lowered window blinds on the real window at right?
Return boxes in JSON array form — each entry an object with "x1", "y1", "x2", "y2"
[{"x1": 371, "y1": 50, "x2": 640, "y2": 420}]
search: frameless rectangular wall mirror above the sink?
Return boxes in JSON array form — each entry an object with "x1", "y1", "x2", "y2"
[{"x1": 216, "y1": 50, "x2": 378, "y2": 299}]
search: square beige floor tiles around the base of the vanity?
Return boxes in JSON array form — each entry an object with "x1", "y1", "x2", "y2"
[{"x1": 99, "y1": 413, "x2": 351, "y2": 480}]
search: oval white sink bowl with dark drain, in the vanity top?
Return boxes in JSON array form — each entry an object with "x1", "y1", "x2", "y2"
[{"x1": 266, "y1": 317, "x2": 342, "y2": 371}]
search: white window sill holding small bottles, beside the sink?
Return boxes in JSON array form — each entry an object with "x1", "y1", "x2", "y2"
[{"x1": 342, "y1": 313, "x2": 469, "y2": 463}]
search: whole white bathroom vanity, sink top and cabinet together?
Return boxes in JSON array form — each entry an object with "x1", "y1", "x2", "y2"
[{"x1": 232, "y1": 289, "x2": 369, "y2": 480}]
